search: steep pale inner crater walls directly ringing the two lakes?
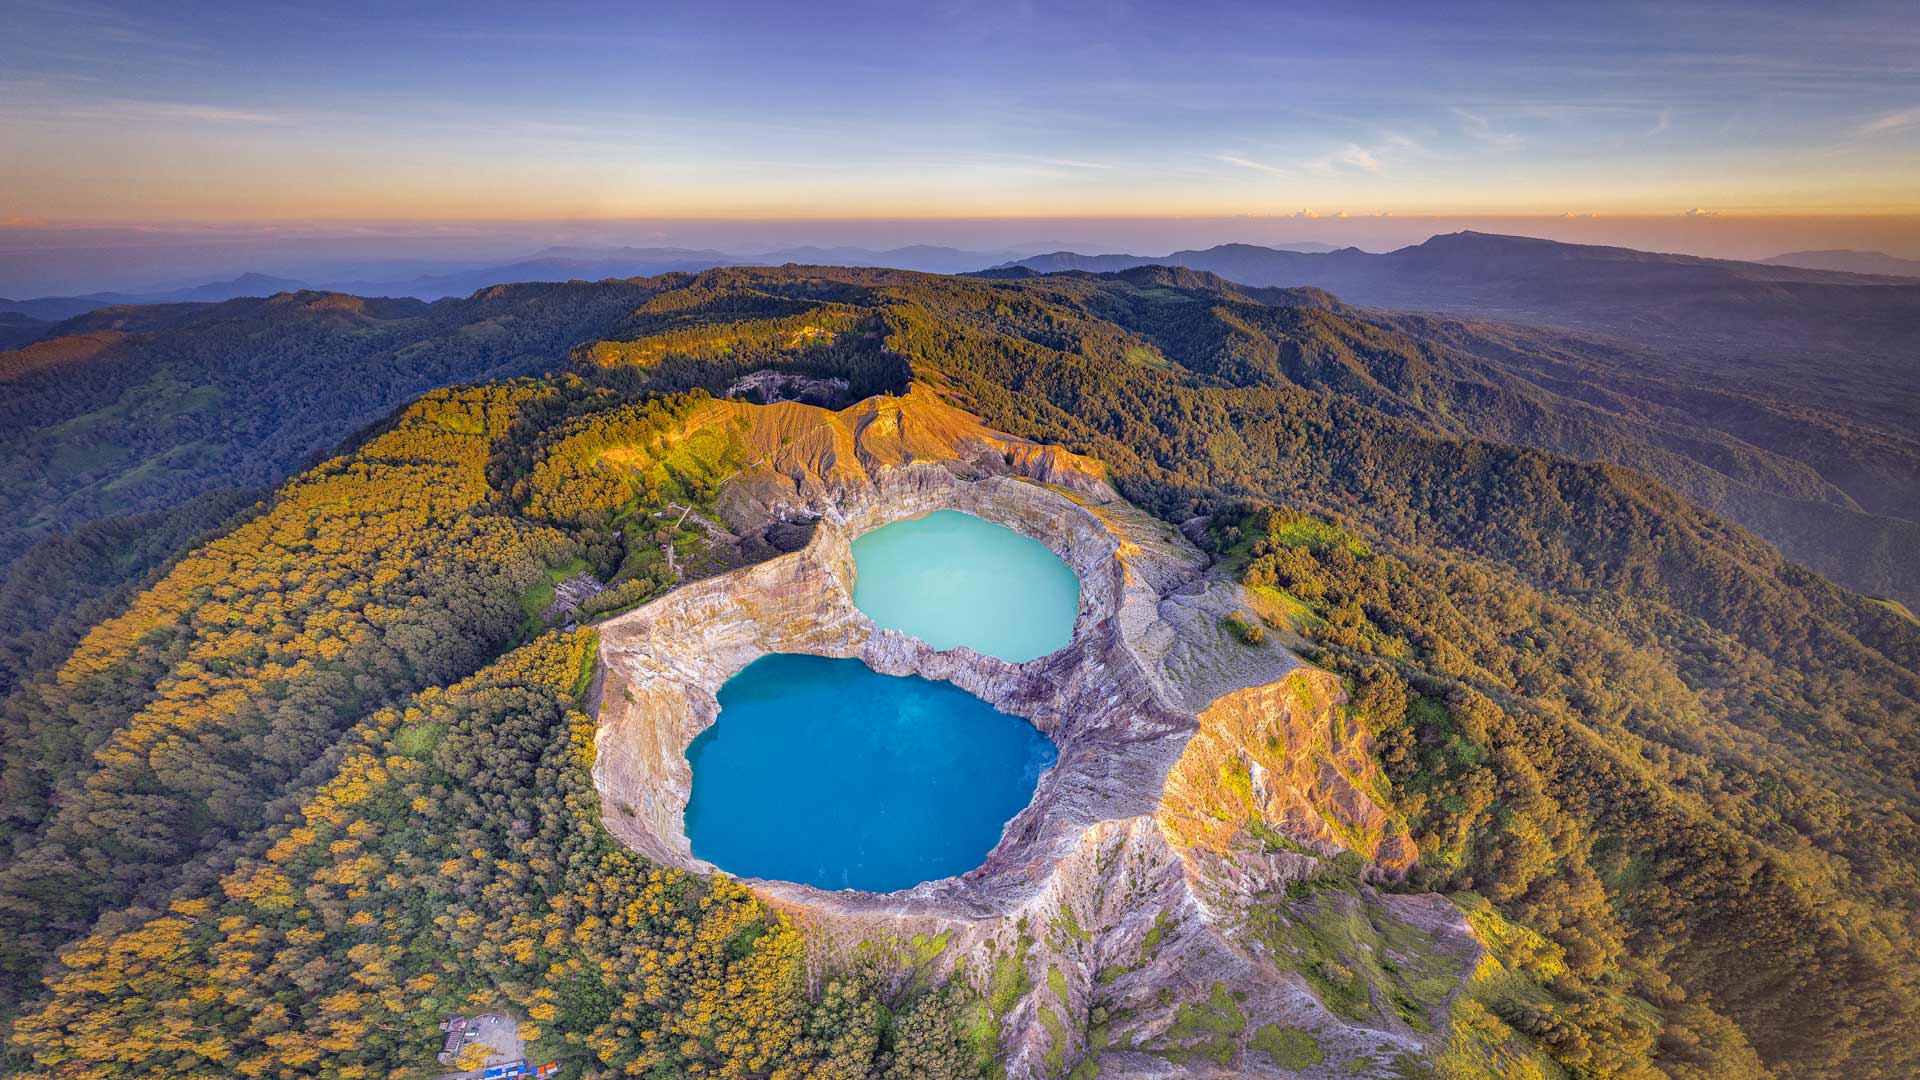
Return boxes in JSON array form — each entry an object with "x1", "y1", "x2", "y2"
[{"x1": 595, "y1": 463, "x2": 1202, "y2": 915}]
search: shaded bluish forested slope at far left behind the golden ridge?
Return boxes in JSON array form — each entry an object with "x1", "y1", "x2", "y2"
[{"x1": 0, "y1": 282, "x2": 687, "y2": 567}]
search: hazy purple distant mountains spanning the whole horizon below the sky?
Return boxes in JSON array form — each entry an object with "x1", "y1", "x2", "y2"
[{"x1": 0, "y1": 233, "x2": 1920, "y2": 598}]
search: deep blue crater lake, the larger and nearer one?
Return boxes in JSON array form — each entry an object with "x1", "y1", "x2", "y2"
[{"x1": 687, "y1": 653, "x2": 1056, "y2": 892}]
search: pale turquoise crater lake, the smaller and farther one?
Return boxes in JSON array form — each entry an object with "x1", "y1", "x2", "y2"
[{"x1": 852, "y1": 509, "x2": 1079, "y2": 663}]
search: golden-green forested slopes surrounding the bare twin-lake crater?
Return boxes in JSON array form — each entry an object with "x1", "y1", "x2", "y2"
[{"x1": 0, "y1": 267, "x2": 1920, "y2": 1080}]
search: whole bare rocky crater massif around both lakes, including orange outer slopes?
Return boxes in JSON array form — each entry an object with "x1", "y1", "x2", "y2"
[{"x1": 593, "y1": 386, "x2": 1484, "y2": 1076}]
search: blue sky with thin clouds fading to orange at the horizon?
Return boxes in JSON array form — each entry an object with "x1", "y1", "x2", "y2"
[{"x1": 0, "y1": 0, "x2": 1920, "y2": 254}]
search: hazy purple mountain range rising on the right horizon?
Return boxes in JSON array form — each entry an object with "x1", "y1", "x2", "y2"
[{"x1": 981, "y1": 233, "x2": 1920, "y2": 409}]
